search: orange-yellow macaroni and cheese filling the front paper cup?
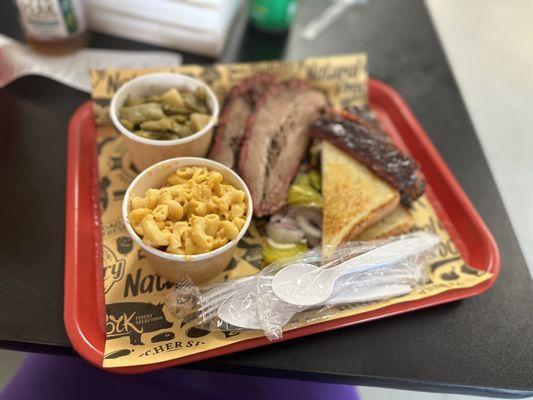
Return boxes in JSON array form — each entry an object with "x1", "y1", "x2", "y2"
[{"x1": 128, "y1": 167, "x2": 247, "y2": 255}]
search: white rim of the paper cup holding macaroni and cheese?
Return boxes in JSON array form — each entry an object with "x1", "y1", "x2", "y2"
[{"x1": 122, "y1": 157, "x2": 253, "y2": 262}]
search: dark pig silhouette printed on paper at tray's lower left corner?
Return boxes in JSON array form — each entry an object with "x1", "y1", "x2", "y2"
[{"x1": 106, "y1": 302, "x2": 173, "y2": 346}]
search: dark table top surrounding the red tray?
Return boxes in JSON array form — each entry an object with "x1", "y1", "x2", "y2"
[{"x1": 0, "y1": 0, "x2": 533, "y2": 396}]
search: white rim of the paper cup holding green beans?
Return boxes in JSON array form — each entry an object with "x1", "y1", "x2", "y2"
[{"x1": 109, "y1": 72, "x2": 220, "y2": 147}]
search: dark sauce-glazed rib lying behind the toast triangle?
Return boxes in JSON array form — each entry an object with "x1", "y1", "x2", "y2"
[{"x1": 310, "y1": 115, "x2": 426, "y2": 206}]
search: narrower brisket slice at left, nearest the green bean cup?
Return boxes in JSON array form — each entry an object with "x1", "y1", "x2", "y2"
[{"x1": 209, "y1": 74, "x2": 276, "y2": 168}]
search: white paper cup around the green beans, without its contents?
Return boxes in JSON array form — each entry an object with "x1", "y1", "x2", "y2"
[{"x1": 109, "y1": 73, "x2": 220, "y2": 171}]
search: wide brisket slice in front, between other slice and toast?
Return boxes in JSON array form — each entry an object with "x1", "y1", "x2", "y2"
[{"x1": 238, "y1": 80, "x2": 326, "y2": 217}]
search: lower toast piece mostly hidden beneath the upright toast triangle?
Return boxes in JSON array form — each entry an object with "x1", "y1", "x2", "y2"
[{"x1": 356, "y1": 206, "x2": 415, "y2": 240}]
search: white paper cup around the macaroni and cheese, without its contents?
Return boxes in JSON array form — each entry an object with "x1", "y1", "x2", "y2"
[{"x1": 122, "y1": 157, "x2": 253, "y2": 284}]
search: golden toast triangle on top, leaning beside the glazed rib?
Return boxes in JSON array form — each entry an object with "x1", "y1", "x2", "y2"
[{"x1": 322, "y1": 141, "x2": 400, "y2": 247}]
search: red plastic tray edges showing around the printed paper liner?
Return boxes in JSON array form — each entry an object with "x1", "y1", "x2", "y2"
[{"x1": 64, "y1": 80, "x2": 500, "y2": 373}]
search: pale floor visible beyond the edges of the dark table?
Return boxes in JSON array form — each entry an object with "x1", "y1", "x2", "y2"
[{"x1": 0, "y1": 0, "x2": 533, "y2": 400}]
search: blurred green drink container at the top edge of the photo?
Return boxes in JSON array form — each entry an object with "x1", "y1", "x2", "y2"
[{"x1": 250, "y1": 0, "x2": 298, "y2": 32}]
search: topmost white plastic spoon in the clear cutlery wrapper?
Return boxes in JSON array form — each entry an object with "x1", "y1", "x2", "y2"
[{"x1": 272, "y1": 233, "x2": 439, "y2": 306}]
